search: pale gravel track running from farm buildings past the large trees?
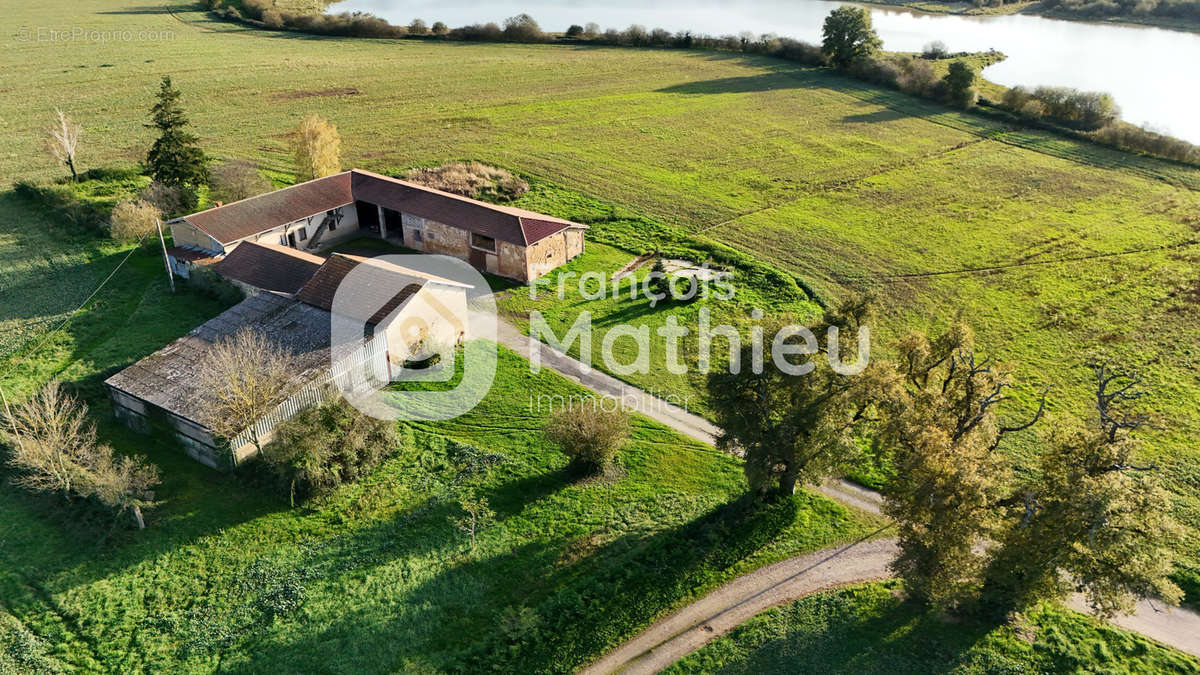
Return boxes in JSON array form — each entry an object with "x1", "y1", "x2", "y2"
[{"x1": 484, "y1": 321, "x2": 1200, "y2": 673}]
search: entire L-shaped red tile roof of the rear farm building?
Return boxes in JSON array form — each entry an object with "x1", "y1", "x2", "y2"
[{"x1": 184, "y1": 169, "x2": 587, "y2": 246}]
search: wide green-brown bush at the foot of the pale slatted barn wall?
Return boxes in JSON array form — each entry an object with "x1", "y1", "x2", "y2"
[{"x1": 262, "y1": 395, "x2": 401, "y2": 504}]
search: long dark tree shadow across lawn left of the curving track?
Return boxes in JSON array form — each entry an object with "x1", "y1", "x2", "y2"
[{"x1": 223, "y1": 492, "x2": 798, "y2": 673}]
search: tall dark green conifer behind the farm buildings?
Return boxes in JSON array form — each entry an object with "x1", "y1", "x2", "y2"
[{"x1": 146, "y1": 77, "x2": 209, "y2": 191}]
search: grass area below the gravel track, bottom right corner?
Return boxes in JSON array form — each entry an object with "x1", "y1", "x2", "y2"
[{"x1": 667, "y1": 584, "x2": 1200, "y2": 675}]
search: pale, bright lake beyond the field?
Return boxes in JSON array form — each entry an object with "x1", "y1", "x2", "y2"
[{"x1": 329, "y1": 0, "x2": 1200, "y2": 143}]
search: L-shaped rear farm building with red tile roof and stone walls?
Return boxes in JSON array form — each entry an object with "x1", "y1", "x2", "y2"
[{"x1": 169, "y1": 169, "x2": 587, "y2": 281}]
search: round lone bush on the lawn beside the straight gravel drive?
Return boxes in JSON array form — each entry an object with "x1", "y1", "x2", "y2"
[{"x1": 545, "y1": 402, "x2": 629, "y2": 476}]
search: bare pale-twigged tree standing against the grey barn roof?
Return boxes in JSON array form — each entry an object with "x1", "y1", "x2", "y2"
[{"x1": 200, "y1": 328, "x2": 292, "y2": 450}]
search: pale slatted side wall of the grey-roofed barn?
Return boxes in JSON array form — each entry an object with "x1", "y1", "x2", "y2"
[{"x1": 229, "y1": 334, "x2": 389, "y2": 450}]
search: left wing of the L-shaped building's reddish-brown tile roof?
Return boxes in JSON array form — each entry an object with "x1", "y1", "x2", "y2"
[{"x1": 184, "y1": 172, "x2": 354, "y2": 244}]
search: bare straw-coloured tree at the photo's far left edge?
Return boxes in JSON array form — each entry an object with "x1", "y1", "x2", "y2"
[{"x1": 6, "y1": 382, "x2": 96, "y2": 495}]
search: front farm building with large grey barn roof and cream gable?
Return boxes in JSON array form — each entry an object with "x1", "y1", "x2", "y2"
[{"x1": 106, "y1": 252, "x2": 470, "y2": 470}]
